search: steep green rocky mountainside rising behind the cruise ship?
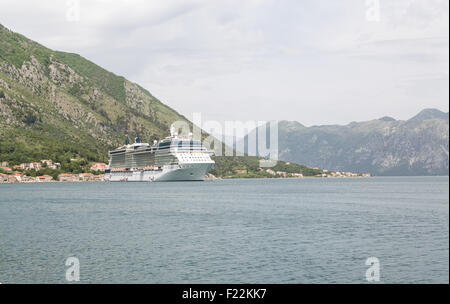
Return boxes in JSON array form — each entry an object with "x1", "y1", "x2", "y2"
[{"x1": 0, "y1": 24, "x2": 322, "y2": 177}]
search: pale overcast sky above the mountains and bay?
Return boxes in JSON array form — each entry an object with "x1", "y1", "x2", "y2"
[{"x1": 0, "y1": 0, "x2": 449, "y2": 126}]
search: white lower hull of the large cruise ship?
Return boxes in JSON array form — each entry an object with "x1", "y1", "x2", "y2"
[{"x1": 105, "y1": 163, "x2": 214, "y2": 182}]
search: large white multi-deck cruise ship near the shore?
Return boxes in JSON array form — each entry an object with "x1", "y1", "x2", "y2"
[{"x1": 105, "y1": 130, "x2": 214, "y2": 182}]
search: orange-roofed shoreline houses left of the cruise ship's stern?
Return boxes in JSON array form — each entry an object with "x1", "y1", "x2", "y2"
[{"x1": 0, "y1": 159, "x2": 108, "y2": 183}]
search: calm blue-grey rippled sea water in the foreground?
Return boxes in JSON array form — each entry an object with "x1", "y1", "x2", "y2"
[{"x1": 0, "y1": 177, "x2": 449, "y2": 283}]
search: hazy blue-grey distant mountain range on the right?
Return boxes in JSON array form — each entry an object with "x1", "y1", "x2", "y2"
[{"x1": 239, "y1": 109, "x2": 449, "y2": 175}]
